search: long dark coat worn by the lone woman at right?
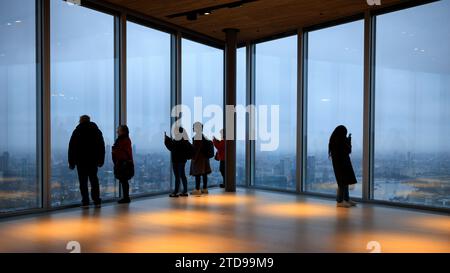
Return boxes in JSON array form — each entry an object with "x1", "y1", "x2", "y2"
[{"x1": 331, "y1": 139, "x2": 358, "y2": 186}]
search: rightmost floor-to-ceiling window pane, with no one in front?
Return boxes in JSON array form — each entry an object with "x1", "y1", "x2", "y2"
[{"x1": 373, "y1": 0, "x2": 450, "y2": 208}]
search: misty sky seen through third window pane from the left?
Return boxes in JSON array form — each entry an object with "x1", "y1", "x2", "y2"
[{"x1": 127, "y1": 22, "x2": 170, "y2": 153}]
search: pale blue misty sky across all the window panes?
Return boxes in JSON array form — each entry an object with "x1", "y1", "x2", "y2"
[{"x1": 0, "y1": 0, "x2": 450, "y2": 158}]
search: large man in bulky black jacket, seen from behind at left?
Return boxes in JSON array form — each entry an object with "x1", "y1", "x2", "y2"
[{"x1": 68, "y1": 115, "x2": 105, "y2": 208}]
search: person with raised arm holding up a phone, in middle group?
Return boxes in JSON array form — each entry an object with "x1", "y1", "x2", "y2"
[{"x1": 164, "y1": 127, "x2": 192, "y2": 197}]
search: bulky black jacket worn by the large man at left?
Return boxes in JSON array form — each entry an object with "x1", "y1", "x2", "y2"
[{"x1": 68, "y1": 122, "x2": 105, "y2": 167}]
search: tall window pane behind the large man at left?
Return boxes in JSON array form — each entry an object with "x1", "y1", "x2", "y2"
[{"x1": 51, "y1": 0, "x2": 117, "y2": 206}]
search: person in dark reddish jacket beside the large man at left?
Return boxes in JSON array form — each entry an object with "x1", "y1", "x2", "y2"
[{"x1": 112, "y1": 125, "x2": 134, "y2": 204}]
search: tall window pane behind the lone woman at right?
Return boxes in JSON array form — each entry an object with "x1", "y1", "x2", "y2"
[{"x1": 305, "y1": 20, "x2": 364, "y2": 197}]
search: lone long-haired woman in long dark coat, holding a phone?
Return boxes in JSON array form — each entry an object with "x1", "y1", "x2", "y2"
[{"x1": 328, "y1": 125, "x2": 357, "y2": 208}]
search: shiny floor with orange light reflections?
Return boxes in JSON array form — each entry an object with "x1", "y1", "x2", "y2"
[{"x1": 0, "y1": 190, "x2": 450, "y2": 252}]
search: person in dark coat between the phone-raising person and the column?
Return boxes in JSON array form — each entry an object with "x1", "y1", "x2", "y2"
[{"x1": 190, "y1": 122, "x2": 214, "y2": 196}]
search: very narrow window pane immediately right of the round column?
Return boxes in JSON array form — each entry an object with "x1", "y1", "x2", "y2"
[{"x1": 236, "y1": 47, "x2": 247, "y2": 185}]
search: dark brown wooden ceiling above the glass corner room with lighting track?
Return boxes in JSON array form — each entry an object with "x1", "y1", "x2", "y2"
[{"x1": 105, "y1": 0, "x2": 405, "y2": 42}]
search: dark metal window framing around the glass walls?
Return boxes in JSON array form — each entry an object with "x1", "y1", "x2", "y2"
[{"x1": 0, "y1": 0, "x2": 450, "y2": 219}]
